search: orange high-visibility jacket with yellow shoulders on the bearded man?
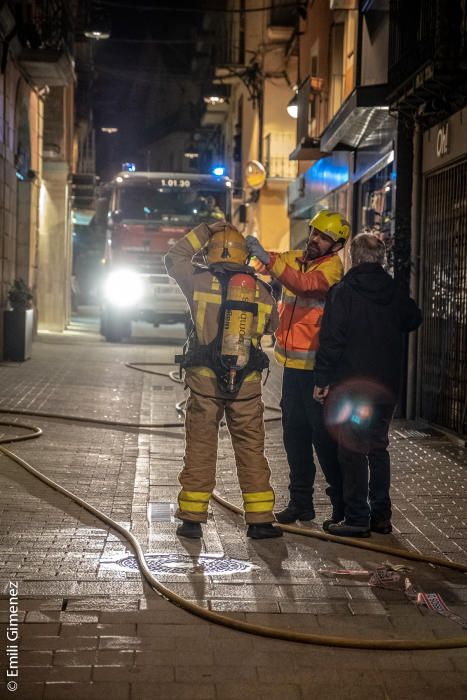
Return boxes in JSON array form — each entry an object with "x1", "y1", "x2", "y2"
[{"x1": 266, "y1": 250, "x2": 344, "y2": 370}]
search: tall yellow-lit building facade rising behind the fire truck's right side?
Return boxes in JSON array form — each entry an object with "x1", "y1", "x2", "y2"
[{"x1": 202, "y1": 0, "x2": 299, "y2": 250}]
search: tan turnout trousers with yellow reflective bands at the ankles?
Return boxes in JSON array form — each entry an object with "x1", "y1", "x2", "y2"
[{"x1": 176, "y1": 390, "x2": 275, "y2": 524}]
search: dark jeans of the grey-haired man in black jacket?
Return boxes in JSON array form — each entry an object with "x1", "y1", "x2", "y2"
[{"x1": 338, "y1": 404, "x2": 394, "y2": 527}]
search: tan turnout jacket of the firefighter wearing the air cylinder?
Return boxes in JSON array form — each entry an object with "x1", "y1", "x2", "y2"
[{"x1": 165, "y1": 224, "x2": 278, "y2": 399}]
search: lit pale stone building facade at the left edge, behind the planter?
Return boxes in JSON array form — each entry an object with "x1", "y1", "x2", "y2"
[{"x1": 0, "y1": 0, "x2": 81, "y2": 352}]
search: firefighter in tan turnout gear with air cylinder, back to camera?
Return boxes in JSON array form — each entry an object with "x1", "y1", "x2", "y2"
[{"x1": 165, "y1": 221, "x2": 282, "y2": 539}]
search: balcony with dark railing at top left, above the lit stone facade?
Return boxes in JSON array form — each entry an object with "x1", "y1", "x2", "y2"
[{"x1": 18, "y1": 0, "x2": 75, "y2": 87}]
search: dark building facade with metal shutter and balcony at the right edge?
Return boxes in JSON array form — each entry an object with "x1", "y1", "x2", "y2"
[{"x1": 388, "y1": 0, "x2": 467, "y2": 436}]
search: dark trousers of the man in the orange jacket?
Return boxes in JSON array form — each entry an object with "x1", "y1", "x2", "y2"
[{"x1": 281, "y1": 368, "x2": 344, "y2": 519}]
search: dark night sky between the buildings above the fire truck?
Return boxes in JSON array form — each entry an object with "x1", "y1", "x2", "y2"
[{"x1": 93, "y1": 0, "x2": 207, "y2": 178}]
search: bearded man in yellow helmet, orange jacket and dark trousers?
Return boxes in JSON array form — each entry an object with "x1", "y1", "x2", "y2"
[{"x1": 246, "y1": 209, "x2": 350, "y2": 523}]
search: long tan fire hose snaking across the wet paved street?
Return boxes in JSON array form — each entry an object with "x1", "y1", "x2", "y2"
[{"x1": 0, "y1": 363, "x2": 467, "y2": 651}]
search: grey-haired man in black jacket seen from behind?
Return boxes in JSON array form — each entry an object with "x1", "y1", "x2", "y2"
[{"x1": 314, "y1": 233, "x2": 422, "y2": 537}]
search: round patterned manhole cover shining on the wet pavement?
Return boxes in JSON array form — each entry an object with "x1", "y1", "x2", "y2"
[{"x1": 113, "y1": 554, "x2": 257, "y2": 576}]
